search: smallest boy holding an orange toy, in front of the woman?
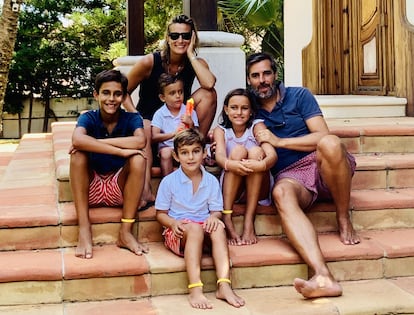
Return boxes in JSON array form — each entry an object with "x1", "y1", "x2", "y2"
[{"x1": 151, "y1": 73, "x2": 198, "y2": 176}]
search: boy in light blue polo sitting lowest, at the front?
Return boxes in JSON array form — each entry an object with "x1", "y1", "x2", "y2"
[{"x1": 155, "y1": 129, "x2": 244, "y2": 309}]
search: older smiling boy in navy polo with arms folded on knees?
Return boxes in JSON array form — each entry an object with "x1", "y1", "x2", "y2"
[{"x1": 69, "y1": 70, "x2": 148, "y2": 258}]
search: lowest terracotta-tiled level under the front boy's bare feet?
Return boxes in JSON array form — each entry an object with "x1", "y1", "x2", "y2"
[{"x1": 0, "y1": 277, "x2": 414, "y2": 315}]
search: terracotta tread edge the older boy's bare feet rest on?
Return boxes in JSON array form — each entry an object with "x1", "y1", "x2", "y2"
[{"x1": 0, "y1": 229, "x2": 414, "y2": 283}]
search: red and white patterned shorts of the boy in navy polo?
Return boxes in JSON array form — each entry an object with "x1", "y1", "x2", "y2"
[{"x1": 89, "y1": 168, "x2": 124, "y2": 207}]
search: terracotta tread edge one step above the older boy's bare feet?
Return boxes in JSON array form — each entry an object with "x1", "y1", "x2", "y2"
[{"x1": 0, "y1": 188, "x2": 414, "y2": 229}]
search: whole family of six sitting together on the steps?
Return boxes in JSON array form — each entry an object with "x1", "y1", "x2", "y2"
[{"x1": 70, "y1": 15, "x2": 360, "y2": 309}]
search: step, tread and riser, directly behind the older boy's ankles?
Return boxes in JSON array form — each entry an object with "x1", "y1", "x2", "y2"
[{"x1": 0, "y1": 188, "x2": 414, "y2": 250}]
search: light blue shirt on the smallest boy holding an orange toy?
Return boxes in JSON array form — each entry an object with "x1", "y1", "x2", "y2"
[{"x1": 151, "y1": 103, "x2": 199, "y2": 150}]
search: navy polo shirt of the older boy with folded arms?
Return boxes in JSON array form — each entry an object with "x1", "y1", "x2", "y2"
[{"x1": 76, "y1": 109, "x2": 144, "y2": 174}]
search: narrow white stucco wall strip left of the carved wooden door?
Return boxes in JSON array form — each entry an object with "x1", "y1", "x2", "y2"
[{"x1": 284, "y1": 0, "x2": 314, "y2": 86}]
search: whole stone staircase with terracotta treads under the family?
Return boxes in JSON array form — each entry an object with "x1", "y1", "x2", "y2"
[{"x1": 0, "y1": 117, "x2": 414, "y2": 314}]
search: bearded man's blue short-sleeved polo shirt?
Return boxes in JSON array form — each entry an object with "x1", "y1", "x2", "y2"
[{"x1": 257, "y1": 83, "x2": 322, "y2": 175}]
